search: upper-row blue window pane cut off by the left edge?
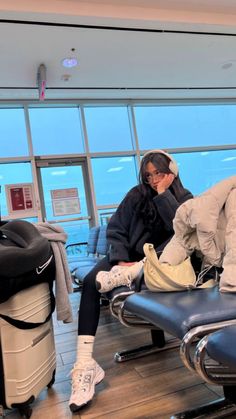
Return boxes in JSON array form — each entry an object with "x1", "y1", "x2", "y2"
[{"x1": 0, "y1": 109, "x2": 29, "y2": 157}]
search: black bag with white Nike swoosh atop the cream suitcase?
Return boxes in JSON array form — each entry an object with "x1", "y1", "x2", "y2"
[{"x1": 0, "y1": 220, "x2": 55, "y2": 303}]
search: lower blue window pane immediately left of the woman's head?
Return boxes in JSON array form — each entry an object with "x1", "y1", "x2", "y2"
[{"x1": 92, "y1": 157, "x2": 137, "y2": 205}]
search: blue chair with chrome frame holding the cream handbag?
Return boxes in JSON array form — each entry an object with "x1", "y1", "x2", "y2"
[{"x1": 115, "y1": 287, "x2": 236, "y2": 371}]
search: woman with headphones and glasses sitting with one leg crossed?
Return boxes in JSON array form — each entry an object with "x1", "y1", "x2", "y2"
[{"x1": 69, "y1": 150, "x2": 192, "y2": 412}]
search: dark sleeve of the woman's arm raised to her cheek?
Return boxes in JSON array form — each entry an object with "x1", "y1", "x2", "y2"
[{"x1": 153, "y1": 189, "x2": 193, "y2": 231}]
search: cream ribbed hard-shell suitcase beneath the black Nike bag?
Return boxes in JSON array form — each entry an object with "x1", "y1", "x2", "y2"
[{"x1": 0, "y1": 283, "x2": 56, "y2": 408}]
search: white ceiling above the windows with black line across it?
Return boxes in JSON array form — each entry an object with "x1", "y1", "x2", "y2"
[{"x1": 0, "y1": 0, "x2": 236, "y2": 101}]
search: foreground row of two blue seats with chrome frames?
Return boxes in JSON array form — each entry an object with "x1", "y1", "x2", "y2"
[{"x1": 111, "y1": 287, "x2": 236, "y2": 419}]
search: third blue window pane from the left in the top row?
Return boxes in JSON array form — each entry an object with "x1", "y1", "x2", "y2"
[{"x1": 84, "y1": 106, "x2": 133, "y2": 152}]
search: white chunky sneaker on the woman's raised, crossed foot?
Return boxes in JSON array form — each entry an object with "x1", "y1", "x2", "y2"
[{"x1": 96, "y1": 260, "x2": 143, "y2": 293}]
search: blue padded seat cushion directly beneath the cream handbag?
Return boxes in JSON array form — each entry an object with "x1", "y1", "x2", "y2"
[{"x1": 124, "y1": 287, "x2": 236, "y2": 339}]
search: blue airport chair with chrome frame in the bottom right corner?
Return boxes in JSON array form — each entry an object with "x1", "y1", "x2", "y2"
[{"x1": 172, "y1": 325, "x2": 236, "y2": 419}]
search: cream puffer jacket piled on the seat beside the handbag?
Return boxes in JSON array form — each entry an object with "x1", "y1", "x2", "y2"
[{"x1": 160, "y1": 176, "x2": 236, "y2": 292}]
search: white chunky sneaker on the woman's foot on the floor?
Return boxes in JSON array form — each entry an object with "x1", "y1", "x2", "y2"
[{"x1": 69, "y1": 359, "x2": 105, "y2": 412}]
